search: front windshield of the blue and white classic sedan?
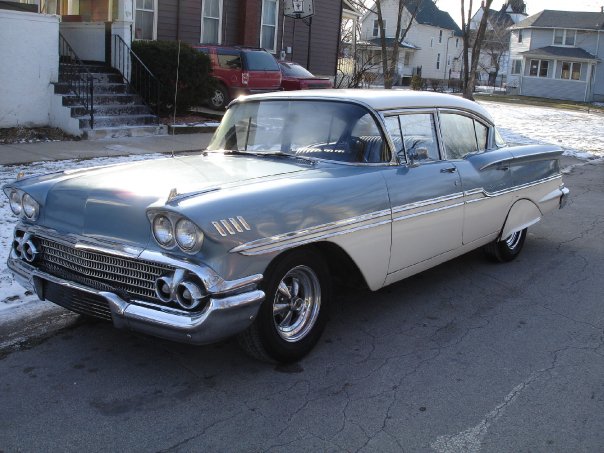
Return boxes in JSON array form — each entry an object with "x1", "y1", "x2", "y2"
[{"x1": 208, "y1": 100, "x2": 387, "y2": 163}]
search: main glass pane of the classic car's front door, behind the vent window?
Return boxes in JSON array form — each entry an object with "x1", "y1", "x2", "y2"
[{"x1": 399, "y1": 113, "x2": 440, "y2": 161}]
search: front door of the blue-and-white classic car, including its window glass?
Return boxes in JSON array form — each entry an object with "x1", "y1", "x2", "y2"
[{"x1": 384, "y1": 111, "x2": 463, "y2": 274}]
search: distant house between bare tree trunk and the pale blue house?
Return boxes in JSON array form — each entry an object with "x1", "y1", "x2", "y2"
[{"x1": 470, "y1": 0, "x2": 528, "y2": 85}]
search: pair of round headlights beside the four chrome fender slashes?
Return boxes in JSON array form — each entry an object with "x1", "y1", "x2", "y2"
[{"x1": 148, "y1": 212, "x2": 203, "y2": 254}]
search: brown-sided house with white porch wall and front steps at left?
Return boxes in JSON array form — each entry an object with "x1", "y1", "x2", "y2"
[{"x1": 0, "y1": 0, "x2": 343, "y2": 137}]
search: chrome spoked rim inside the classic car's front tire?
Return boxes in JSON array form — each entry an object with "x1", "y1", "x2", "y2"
[{"x1": 273, "y1": 266, "x2": 321, "y2": 343}]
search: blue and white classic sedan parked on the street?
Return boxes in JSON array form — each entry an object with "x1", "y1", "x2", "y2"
[{"x1": 3, "y1": 90, "x2": 569, "y2": 362}]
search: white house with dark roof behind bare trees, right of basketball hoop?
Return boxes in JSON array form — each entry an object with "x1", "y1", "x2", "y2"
[{"x1": 359, "y1": 0, "x2": 463, "y2": 84}]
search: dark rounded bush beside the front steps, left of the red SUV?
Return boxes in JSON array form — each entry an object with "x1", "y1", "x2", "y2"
[{"x1": 132, "y1": 41, "x2": 215, "y2": 114}]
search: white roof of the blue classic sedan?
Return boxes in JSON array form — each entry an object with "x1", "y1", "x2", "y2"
[{"x1": 236, "y1": 89, "x2": 493, "y2": 123}]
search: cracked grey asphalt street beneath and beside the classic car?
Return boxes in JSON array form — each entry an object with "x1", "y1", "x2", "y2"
[{"x1": 0, "y1": 156, "x2": 604, "y2": 452}]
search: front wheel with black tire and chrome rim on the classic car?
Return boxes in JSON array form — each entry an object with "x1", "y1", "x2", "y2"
[{"x1": 238, "y1": 249, "x2": 331, "y2": 363}]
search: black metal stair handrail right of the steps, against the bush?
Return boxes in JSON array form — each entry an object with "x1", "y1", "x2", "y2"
[{"x1": 111, "y1": 35, "x2": 161, "y2": 124}]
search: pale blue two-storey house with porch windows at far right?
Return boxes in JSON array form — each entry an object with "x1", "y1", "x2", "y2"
[{"x1": 508, "y1": 10, "x2": 604, "y2": 102}]
